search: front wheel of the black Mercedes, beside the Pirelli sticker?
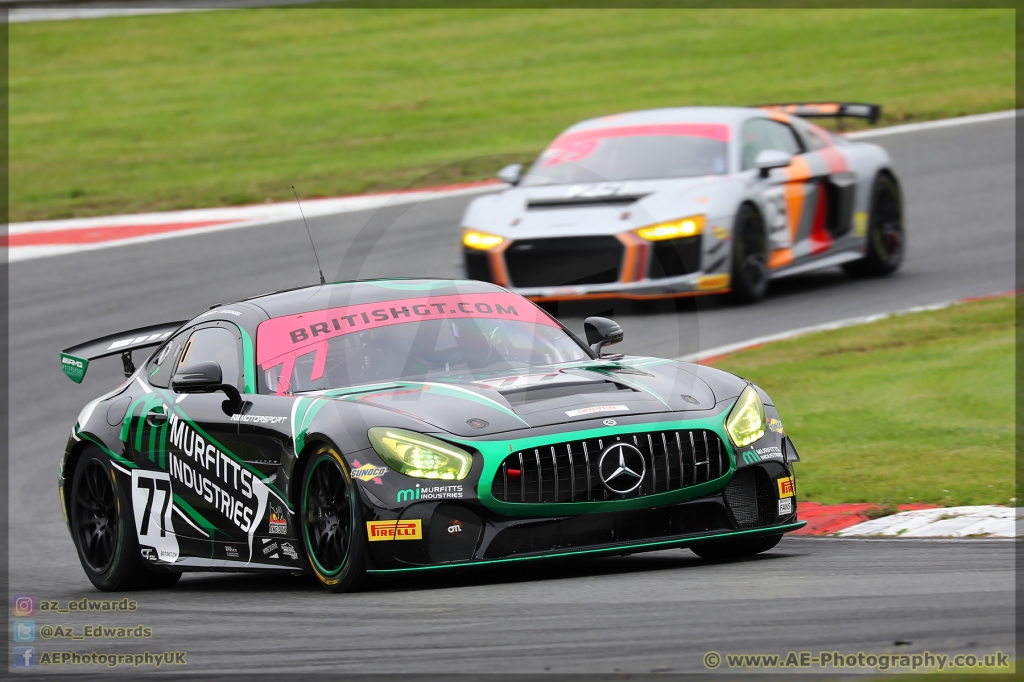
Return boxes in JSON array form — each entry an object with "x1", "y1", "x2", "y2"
[{"x1": 299, "y1": 445, "x2": 367, "y2": 592}]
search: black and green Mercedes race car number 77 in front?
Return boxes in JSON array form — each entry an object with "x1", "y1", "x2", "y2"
[{"x1": 58, "y1": 280, "x2": 803, "y2": 591}]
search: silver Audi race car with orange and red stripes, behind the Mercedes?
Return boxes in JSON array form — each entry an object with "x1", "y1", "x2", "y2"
[{"x1": 462, "y1": 103, "x2": 905, "y2": 302}]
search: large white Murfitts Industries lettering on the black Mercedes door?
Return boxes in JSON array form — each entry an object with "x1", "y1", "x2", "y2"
[{"x1": 168, "y1": 413, "x2": 269, "y2": 548}]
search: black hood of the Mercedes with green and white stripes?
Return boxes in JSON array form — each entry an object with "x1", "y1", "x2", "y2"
[{"x1": 309, "y1": 357, "x2": 745, "y2": 437}]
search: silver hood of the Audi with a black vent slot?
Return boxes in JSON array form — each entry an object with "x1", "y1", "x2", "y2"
[{"x1": 464, "y1": 175, "x2": 732, "y2": 240}]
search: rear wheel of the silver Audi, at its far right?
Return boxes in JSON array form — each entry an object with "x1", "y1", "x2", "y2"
[{"x1": 843, "y1": 173, "x2": 906, "y2": 278}]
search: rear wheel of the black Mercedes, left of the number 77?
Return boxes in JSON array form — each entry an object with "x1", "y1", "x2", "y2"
[{"x1": 68, "y1": 446, "x2": 181, "y2": 592}]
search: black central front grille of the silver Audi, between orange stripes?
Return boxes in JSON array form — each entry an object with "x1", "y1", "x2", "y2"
[{"x1": 505, "y1": 237, "x2": 623, "y2": 287}]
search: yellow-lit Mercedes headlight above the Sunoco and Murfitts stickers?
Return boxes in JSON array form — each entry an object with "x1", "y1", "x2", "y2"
[{"x1": 369, "y1": 427, "x2": 473, "y2": 480}]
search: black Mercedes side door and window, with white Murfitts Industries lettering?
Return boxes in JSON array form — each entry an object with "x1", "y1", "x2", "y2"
[{"x1": 154, "y1": 322, "x2": 267, "y2": 544}]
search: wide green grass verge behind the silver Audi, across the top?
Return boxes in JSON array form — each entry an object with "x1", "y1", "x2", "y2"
[{"x1": 9, "y1": 8, "x2": 1015, "y2": 221}]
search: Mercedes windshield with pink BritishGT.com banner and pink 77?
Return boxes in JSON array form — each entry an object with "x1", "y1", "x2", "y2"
[{"x1": 256, "y1": 293, "x2": 589, "y2": 394}]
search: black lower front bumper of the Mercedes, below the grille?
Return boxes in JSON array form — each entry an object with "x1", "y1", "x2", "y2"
[{"x1": 368, "y1": 462, "x2": 804, "y2": 572}]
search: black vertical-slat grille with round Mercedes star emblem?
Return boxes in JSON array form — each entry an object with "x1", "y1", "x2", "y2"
[{"x1": 490, "y1": 429, "x2": 729, "y2": 503}]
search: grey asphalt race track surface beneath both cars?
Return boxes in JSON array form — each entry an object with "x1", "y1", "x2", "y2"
[{"x1": 9, "y1": 114, "x2": 1015, "y2": 674}]
